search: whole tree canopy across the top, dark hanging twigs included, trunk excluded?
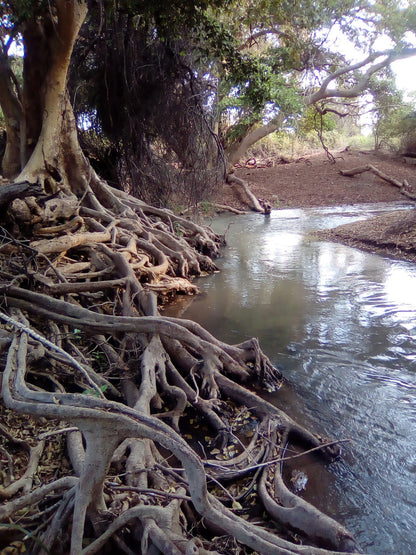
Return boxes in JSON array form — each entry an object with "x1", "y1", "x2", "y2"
[{"x1": 2, "y1": 0, "x2": 416, "y2": 188}]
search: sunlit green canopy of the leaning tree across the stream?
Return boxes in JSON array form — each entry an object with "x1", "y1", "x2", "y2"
[{"x1": 218, "y1": 1, "x2": 416, "y2": 163}]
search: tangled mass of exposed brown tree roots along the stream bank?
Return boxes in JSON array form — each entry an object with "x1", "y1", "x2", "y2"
[{"x1": 0, "y1": 179, "x2": 356, "y2": 555}]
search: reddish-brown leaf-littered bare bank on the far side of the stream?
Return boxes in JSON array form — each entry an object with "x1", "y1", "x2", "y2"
[{"x1": 217, "y1": 151, "x2": 416, "y2": 261}]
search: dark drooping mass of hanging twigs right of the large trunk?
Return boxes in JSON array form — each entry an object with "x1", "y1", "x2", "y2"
[{"x1": 71, "y1": 7, "x2": 229, "y2": 205}]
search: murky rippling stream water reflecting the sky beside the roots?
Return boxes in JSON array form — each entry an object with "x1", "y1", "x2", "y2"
[{"x1": 167, "y1": 204, "x2": 416, "y2": 555}]
